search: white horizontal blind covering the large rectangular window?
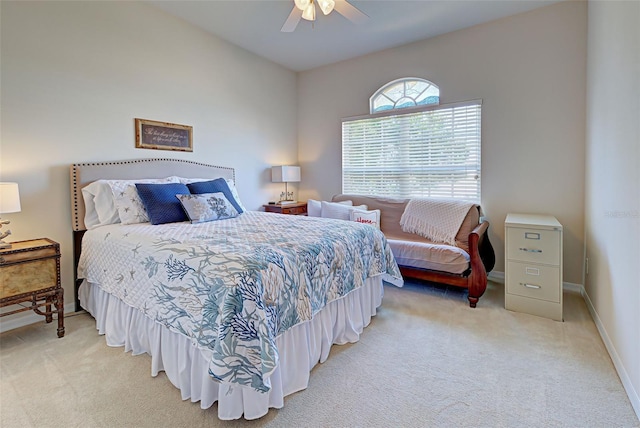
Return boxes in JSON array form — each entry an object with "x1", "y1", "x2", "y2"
[{"x1": 342, "y1": 101, "x2": 481, "y2": 203}]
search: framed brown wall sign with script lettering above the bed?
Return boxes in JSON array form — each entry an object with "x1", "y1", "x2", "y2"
[{"x1": 135, "y1": 118, "x2": 193, "y2": 152}]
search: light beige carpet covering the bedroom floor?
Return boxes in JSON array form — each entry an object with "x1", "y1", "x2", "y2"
[{"x1": 0, "y1": 282, "x2": 640, "y2": 428}]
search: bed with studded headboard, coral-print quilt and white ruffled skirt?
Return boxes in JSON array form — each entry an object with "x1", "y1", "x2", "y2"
[{"x1": 71, "y1": 159, "x2": 402, "y2": 419}]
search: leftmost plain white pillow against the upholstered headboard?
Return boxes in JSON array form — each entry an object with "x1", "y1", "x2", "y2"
[{"x1": 82, "y1": 180, "x2": 120, "y2": 229}]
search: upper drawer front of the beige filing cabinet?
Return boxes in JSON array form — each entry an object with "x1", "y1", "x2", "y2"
[{"x1": 507, "y1": 227, "x2": 561, "y2": 265}]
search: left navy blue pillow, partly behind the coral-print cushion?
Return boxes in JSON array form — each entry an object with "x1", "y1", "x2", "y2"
[{"x1": 136, "y1": 183, "x2": 189, "y2": 224}]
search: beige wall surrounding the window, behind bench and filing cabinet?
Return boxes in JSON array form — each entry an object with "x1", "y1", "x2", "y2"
[{"x1": 298, "y1": 2, "x2": 587, "y2": 284}]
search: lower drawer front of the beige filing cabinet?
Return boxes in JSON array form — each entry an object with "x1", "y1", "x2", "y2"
[{"x1": 506, "y1": 262, "x2": 561, "y2": 302}]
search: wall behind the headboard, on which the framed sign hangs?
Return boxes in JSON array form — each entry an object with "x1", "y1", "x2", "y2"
[{"x1": 0, "y1": 1, "x2": 297, "y2": 325}]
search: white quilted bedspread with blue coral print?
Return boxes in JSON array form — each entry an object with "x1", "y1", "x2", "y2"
[{"x1": 78, "y1": 212, "x2": 402, "y2": 391}]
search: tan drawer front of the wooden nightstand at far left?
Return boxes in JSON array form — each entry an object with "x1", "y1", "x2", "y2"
[{"x1": 0, "y1": 258, "x2": 58, "y2": 299}]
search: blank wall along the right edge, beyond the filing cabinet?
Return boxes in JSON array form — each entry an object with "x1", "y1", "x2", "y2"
[{"x1": 585, "y1": 1, "x2": 640, "y2": 417}]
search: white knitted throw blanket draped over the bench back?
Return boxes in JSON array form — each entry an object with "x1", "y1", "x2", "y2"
[{"x1": 400, "y1": 198, "x2": 475, "y2": 245}]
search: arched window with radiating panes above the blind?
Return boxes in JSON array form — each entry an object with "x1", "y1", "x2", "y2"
[{"x1": 369, "y1": 77, "x2": 440, "y2": 114}]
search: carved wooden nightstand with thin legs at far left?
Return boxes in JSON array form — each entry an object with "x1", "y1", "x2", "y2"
[{"x1": 0, "y1": 238, "x2": 64, "y2": 337}]
